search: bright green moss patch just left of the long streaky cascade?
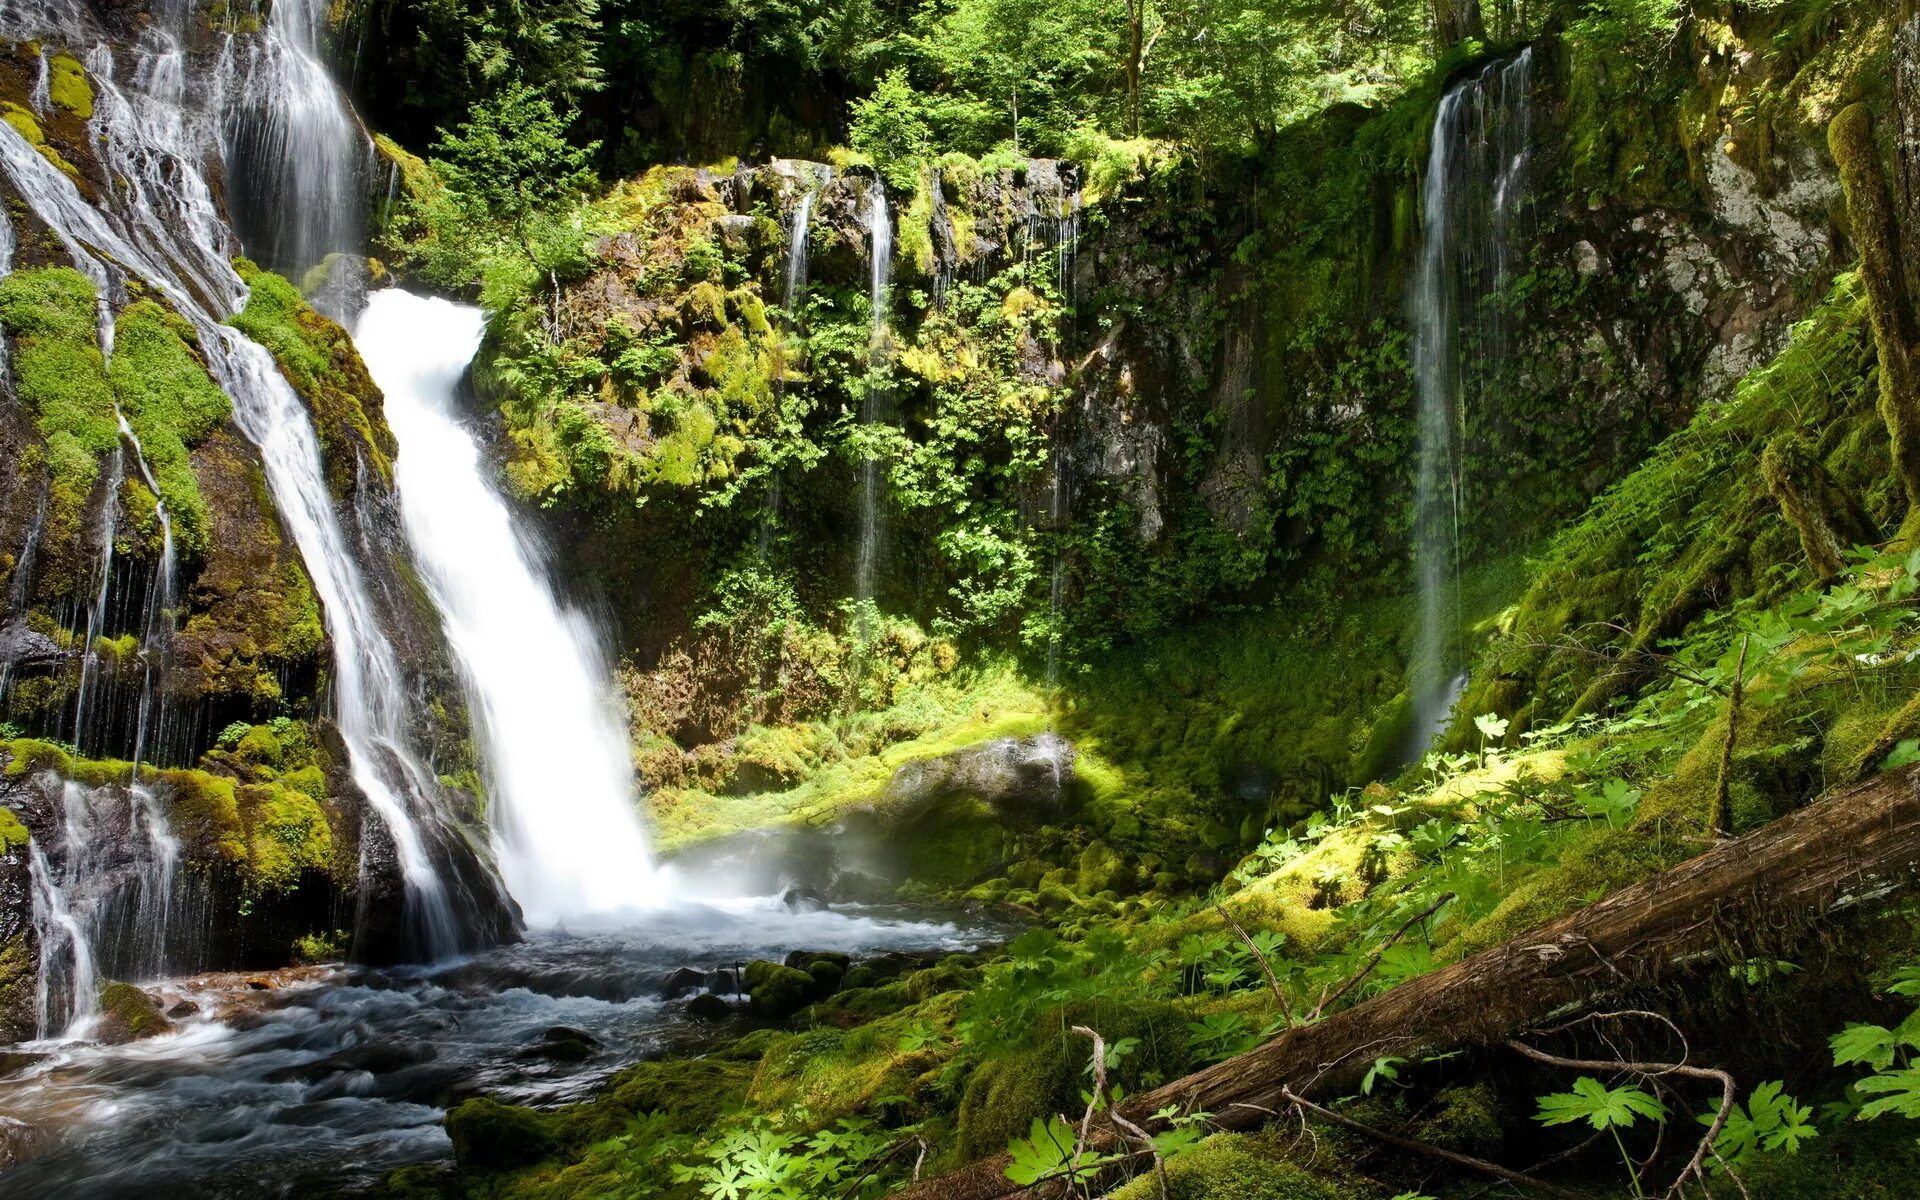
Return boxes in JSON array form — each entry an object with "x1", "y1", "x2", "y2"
[{"x1": 109, "y1": 300, "x2": 232, "y2": 555}]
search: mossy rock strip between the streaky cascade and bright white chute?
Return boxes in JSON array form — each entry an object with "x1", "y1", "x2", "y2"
[{"x1": 232, "y1": 259, "x2": 396, "y2": 497}]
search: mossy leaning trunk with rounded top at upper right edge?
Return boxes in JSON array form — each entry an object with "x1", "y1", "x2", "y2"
[{"x1": 1826, "y1": 104, "x2": 1920, "y2": 511}]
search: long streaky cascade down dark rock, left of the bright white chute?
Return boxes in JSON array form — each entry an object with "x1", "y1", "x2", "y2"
[{"x1": 0, "y1": 4, "x2": 497, "y2": 958}]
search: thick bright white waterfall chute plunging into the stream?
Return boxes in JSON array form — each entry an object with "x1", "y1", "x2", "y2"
[{"x1": 355, "y1": 288, "x2": 659, "y2": 924}]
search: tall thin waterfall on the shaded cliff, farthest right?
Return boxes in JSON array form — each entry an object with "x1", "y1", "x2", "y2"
[{"x1": 1407, "y1": 50, "x2": 1532, "y2": 758}]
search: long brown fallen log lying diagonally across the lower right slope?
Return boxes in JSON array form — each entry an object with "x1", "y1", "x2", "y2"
[{"x1": 900, "y1": 768, "x2": 1920, "y2": 1200}]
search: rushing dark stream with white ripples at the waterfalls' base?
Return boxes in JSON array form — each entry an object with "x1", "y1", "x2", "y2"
[{"x1": 0, "y1": 899, "x2": 996, "y2": 1200}]
